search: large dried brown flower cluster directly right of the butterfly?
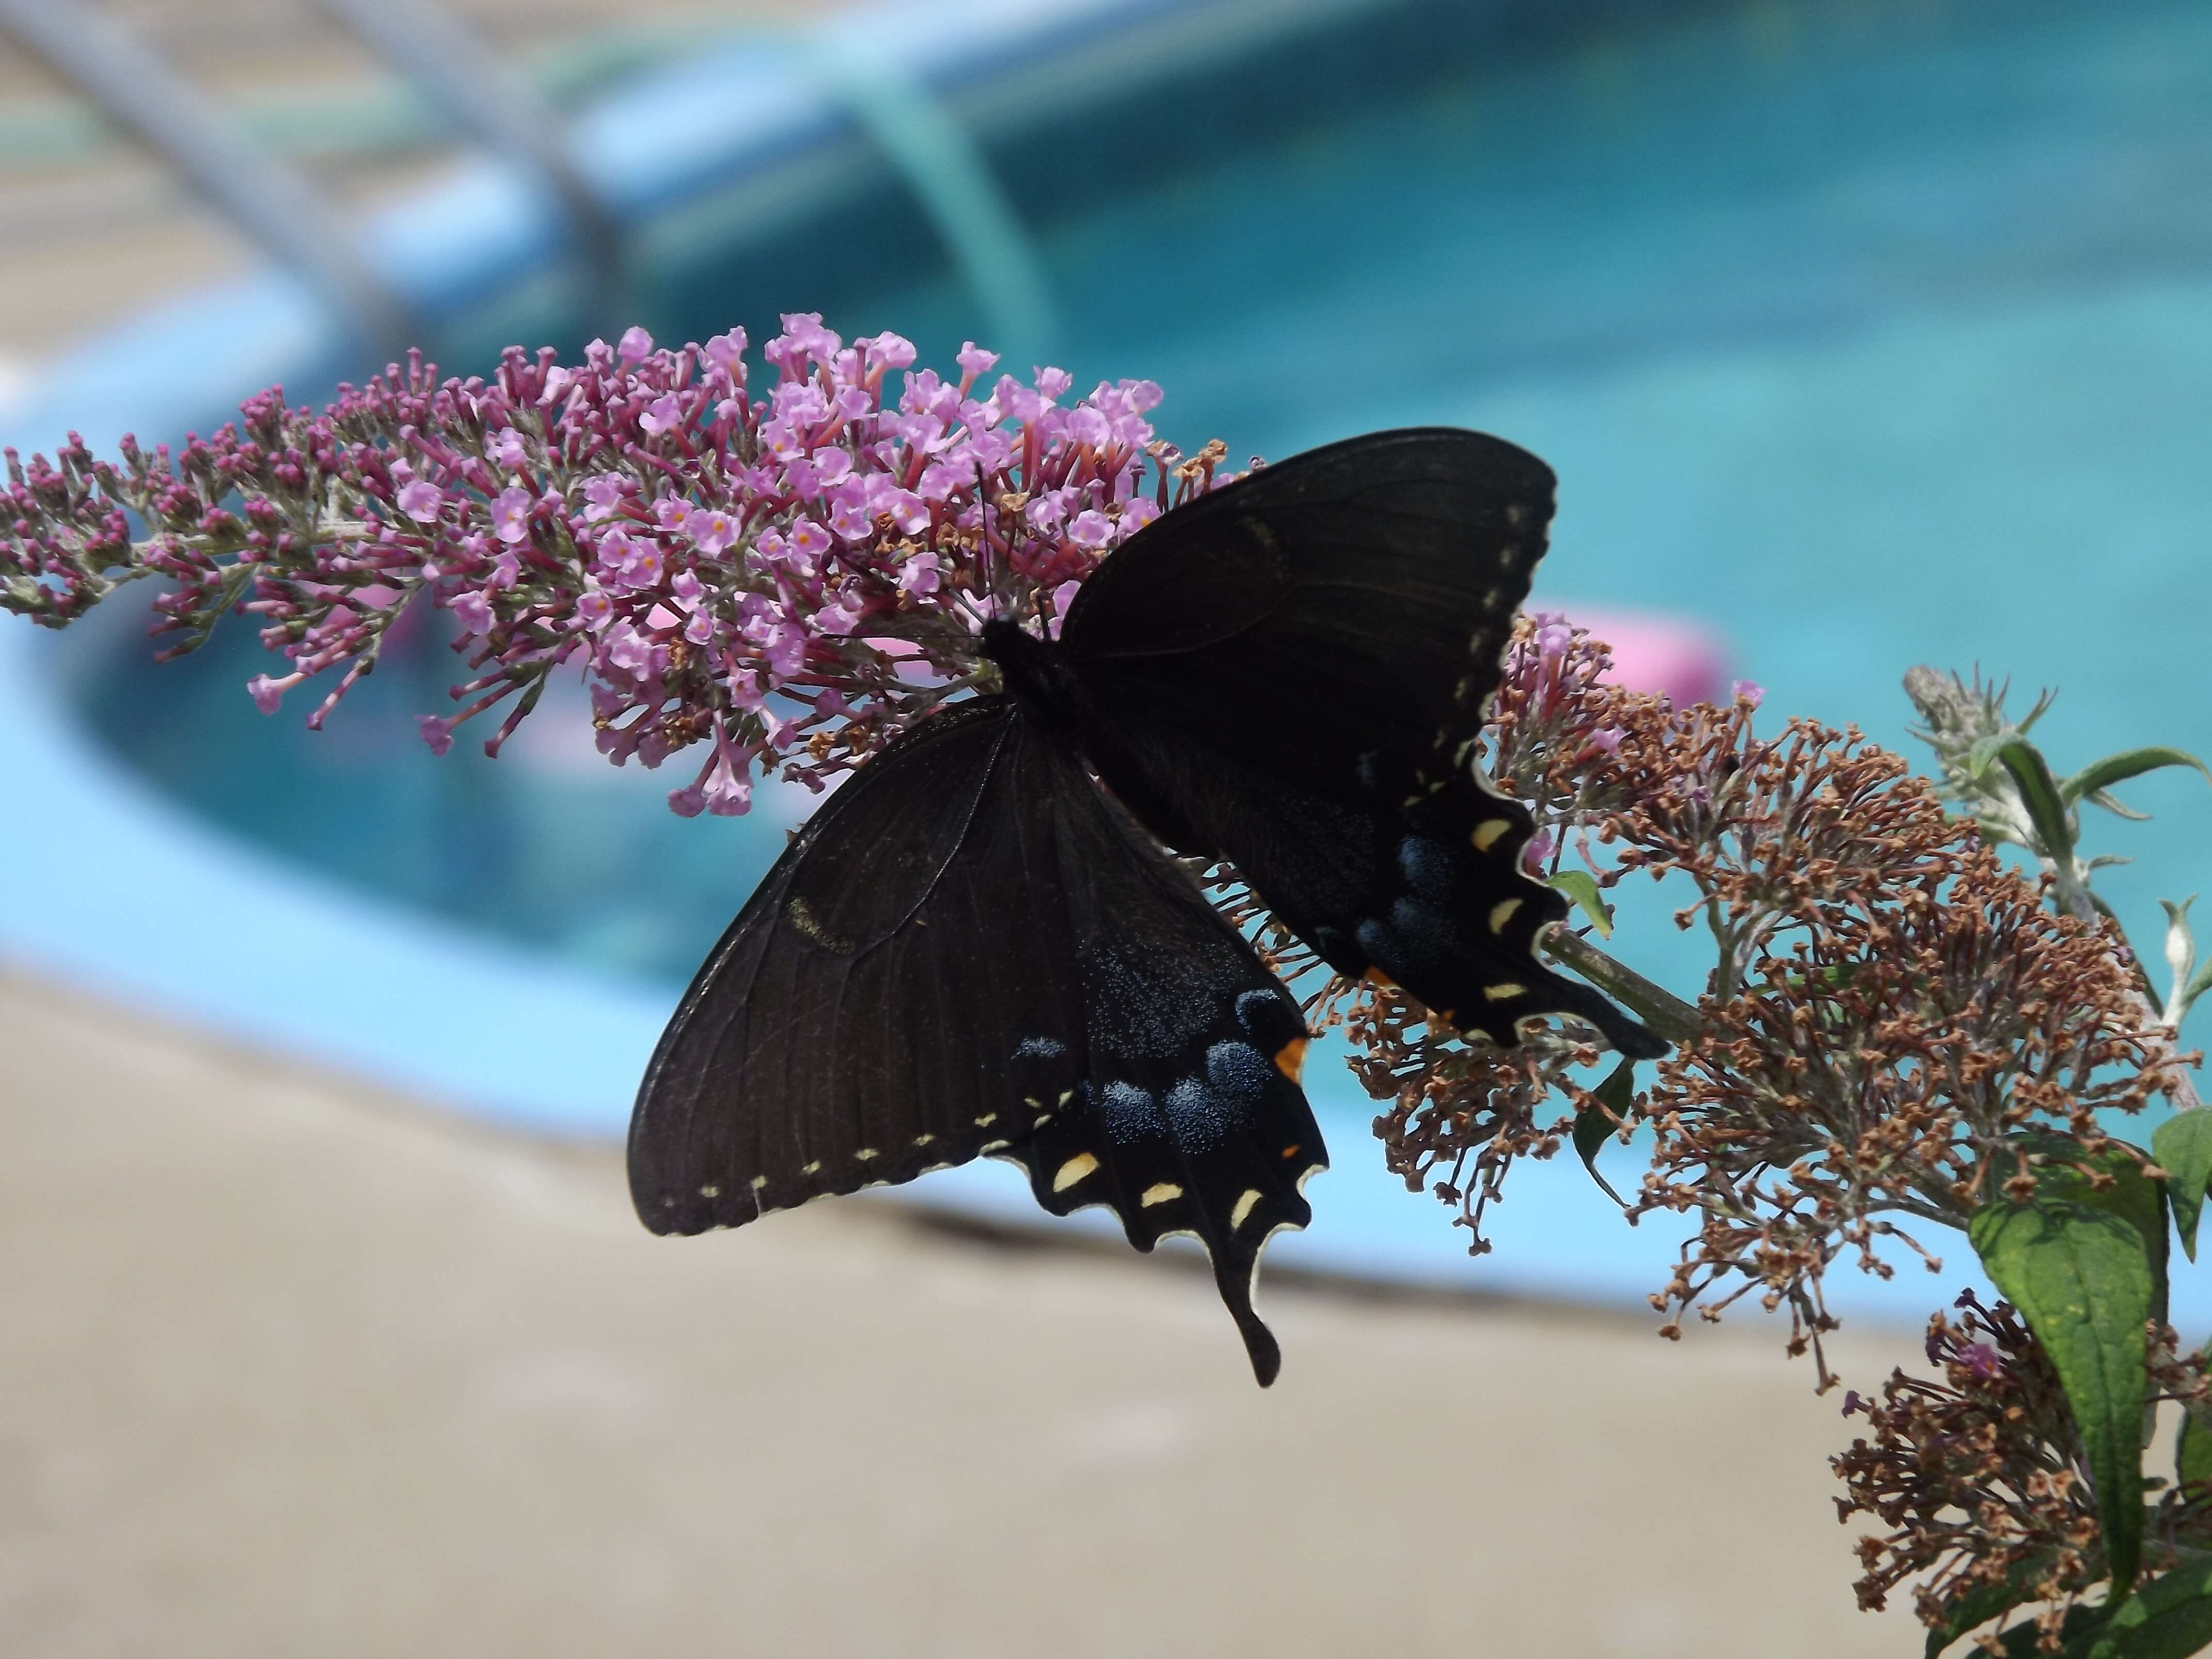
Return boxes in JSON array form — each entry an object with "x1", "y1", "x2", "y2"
[{"x1": 1354, "y1": 617, "x2": 2164, "y2": 1387}]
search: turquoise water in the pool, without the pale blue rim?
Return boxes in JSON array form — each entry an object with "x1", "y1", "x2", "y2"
[{"x1": 82, "y1": 5, "x2": 2212, "y2": 1026}]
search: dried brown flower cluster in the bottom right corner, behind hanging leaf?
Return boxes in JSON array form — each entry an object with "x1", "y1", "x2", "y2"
[{"x1": 1831, "y1": 1294, "x2": 2212, "y2": 1652}]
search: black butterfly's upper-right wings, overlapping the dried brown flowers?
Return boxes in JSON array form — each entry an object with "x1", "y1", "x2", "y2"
[{"x1": 1060, "y1": 429, "x2": 1664, "y2": 1055}]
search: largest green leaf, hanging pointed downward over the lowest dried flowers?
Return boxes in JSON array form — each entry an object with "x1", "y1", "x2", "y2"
[{"x1": 1966, "y1": 1183, "x2": 2164, "y2": 1592}]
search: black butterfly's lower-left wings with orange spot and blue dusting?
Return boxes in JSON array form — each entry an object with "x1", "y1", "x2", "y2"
[{"x1": 630, "y1": 697, "x2": 1325, "y2": 1382}]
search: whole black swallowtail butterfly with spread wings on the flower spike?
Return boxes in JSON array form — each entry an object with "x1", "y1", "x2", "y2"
[{"x1": 630, "y1": 429, "x2": 1664, "y2": 1385}]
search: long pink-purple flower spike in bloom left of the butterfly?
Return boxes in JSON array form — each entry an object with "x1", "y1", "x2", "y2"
[{"x1": 0, "y1": 314, "x2": 1221, "y2": 814}]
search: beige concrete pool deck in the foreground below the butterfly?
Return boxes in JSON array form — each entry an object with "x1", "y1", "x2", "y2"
[{"x1": 0, "y1": 973, "x2": 1920, "y2": 1659}]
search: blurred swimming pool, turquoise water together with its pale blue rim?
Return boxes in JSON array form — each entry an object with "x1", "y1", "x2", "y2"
[{"x1": 7, "y1": 2, "x2": 2212, "y2": 1314}]
